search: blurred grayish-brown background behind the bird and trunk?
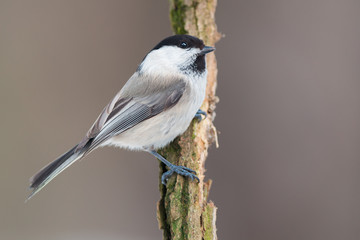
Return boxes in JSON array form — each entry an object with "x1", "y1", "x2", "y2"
[{"x1": 0, "y1": 0, "x2": 360, "y2": 240}]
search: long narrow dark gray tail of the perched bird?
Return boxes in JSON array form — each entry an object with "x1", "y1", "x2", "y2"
[{"x1": 26, "y1": 145, "x2": 85, "y2": 201}]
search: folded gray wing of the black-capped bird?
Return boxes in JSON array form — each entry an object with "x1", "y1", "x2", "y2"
[{"x1": 77, "y1": 79, "x2": 186, "y2": 152}]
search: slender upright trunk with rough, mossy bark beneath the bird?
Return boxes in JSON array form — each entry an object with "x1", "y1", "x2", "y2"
[{"x1": 157, "y1": 0, "x2": 220, "y2": 240}]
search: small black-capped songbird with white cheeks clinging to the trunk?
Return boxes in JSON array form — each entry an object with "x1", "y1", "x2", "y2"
[{"x1": 28, "y1": 35, "x2": 215, "y2": 199}]
